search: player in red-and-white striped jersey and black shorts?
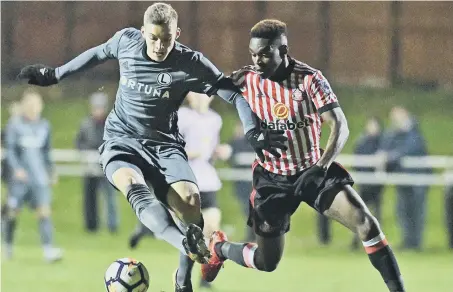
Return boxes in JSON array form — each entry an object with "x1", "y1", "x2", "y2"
[{"x1": 202, "y1": 20, "x2": 405, "y2": 292}]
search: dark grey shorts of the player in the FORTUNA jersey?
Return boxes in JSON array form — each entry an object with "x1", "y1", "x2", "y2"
[{"x1": 99, "y1": 137, "x2": 196, "y2": 204}]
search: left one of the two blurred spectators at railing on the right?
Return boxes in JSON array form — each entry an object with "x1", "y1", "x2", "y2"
[{"x1": 352, "y1": 117, "x2": 384, "y2": 249}]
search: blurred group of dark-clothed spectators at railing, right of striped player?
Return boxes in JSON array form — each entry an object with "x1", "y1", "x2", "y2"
[{"x1": 318, "y1": 106, "x2": 453, "y2": 250}]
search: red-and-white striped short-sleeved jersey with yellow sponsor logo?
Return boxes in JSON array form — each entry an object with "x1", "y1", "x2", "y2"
[{"x1": 231, "y1": 59, "x2": 338, "y2": 175}]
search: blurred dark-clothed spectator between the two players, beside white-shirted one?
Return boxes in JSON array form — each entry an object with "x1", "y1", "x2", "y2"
[{"x1": 230, "y1": 122, "x2": 255, "y2": 242}]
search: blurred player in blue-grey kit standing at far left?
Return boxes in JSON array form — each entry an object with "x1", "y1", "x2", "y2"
[{"x1": 3, "y1": 90, "x2": 62, "y2": 262}]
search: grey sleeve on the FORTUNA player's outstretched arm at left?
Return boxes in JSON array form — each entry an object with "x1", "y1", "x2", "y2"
[{"x1": 55, "y1": 29, "x2": 127, "y2": 80}]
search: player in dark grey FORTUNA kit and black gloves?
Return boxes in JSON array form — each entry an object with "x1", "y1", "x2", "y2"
[{"x1": 19, "y1": 3, "x2": 285, "y2": 292}]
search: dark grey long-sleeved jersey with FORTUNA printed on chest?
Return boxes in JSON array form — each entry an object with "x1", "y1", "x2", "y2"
[{"x1": 55, "y1": 28, "x2": 255, "y2": 145}]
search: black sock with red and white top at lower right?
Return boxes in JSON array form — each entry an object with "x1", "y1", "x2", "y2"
[{"x1": 363, "y1": 233, "x2": 405, "y2": 292}]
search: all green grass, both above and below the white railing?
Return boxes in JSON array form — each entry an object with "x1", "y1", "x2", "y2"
[{"x1": 1, "y1": 83, "x2": 453, "y2": 292}]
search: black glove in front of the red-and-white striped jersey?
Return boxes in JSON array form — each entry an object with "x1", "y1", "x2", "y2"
[{"x1": 245, "y1": 129, "x2": 288, "y2": 162}]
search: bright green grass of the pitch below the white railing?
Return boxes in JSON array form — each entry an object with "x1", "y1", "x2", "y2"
[{"x1": 1, "y1": 178, "x2": 453, "y2": 292}]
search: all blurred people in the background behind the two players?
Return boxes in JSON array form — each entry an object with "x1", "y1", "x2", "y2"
[{"x1": 1, "y1": 90, "x2": 453, "y2": 261}]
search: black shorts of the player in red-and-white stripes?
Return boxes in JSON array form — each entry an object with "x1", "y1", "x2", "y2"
[{"x1": 247, "y1": 162, "x2": 354, "y2": 237}]
